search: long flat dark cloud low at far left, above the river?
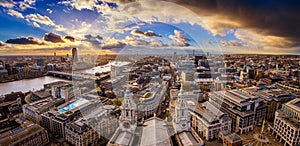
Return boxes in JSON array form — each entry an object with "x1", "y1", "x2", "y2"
[{"x1": 6, "y1": 36, "x2": 44, "y2": 45}]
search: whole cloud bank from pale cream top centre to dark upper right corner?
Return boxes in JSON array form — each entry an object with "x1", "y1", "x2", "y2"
[{"x1": 103, "y1": 0, "x2": 300, "y2": 49}]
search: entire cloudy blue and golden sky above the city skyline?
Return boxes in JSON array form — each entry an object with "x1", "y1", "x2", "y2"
[{"x1": 0, "y1": 0, "x2": 300, "y2": 56}]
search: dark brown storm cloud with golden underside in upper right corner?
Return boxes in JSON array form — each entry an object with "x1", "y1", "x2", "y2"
[{"x1": 167, "y1": 0, "x2": 300, "y2": 47}]
